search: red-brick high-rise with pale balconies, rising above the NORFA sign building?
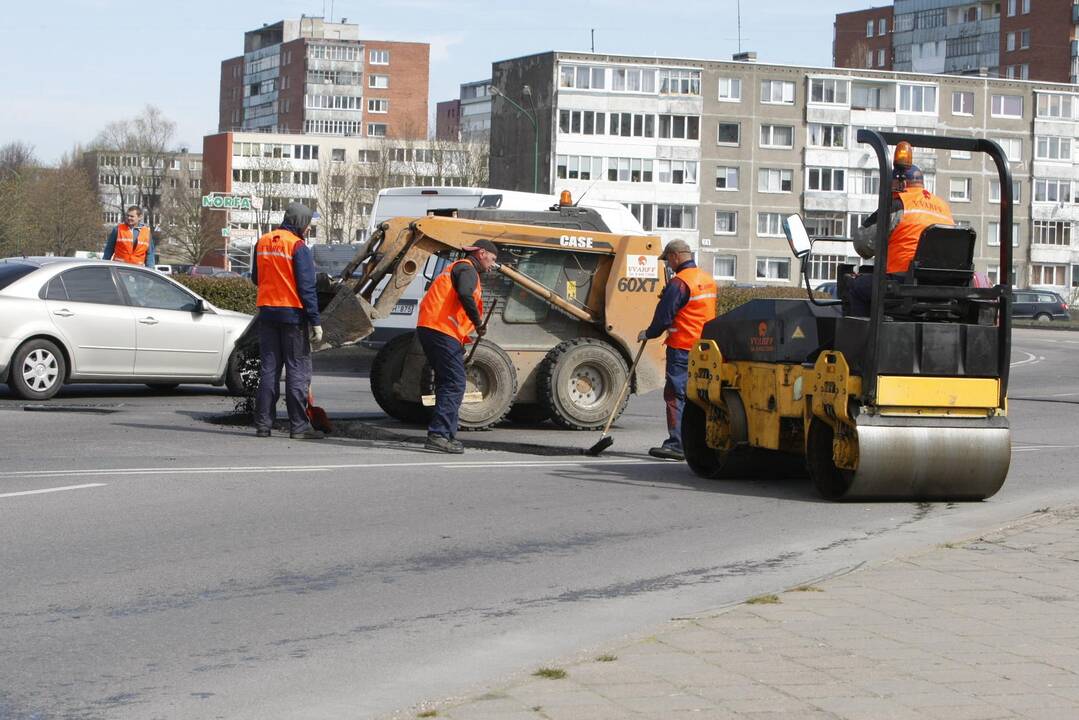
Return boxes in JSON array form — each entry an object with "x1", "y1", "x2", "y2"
[{"x1": 218, "y1": 16, "x2": 431, "y2": 138}]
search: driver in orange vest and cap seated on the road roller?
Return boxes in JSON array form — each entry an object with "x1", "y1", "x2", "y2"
[{"x1": 849, "y1": 152, "x2": 955, "y2": 317}]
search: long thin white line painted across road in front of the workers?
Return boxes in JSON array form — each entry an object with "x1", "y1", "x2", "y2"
[{"x1": 0, "y1": 458, "x2": 669, "y2": 481}]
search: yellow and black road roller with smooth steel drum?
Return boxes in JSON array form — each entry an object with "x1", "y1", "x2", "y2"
[{"x1": 682, "y1": 130, "x2": 1012, "y2": 501}]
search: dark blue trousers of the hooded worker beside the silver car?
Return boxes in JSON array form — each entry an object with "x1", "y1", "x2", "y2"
[{"x1": 255, "y1": 318, "x2": 311, "y2": 433}]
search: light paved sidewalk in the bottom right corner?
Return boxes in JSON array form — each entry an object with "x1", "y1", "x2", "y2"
[{"x1": 395, "y1": 507, "x2": 1079, "y2": 720}]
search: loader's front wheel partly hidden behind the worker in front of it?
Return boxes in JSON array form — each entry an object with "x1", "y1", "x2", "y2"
[{"x1": 423, "y1": 340, "x2": 517, "y2": 431}]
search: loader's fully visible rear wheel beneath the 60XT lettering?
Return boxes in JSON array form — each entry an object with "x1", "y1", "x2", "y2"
[{"x1": 536, "y1": 338, "x2": 629, "y2": 430}]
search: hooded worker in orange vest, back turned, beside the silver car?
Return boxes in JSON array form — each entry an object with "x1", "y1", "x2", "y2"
[{"x1": 251, "y1": 203, "x2": 324, "y2": 440}]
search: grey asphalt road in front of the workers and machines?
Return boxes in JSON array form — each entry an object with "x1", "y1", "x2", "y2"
[{"x1": 0, "y1": 330, "x2": 1079, "y2": 720}]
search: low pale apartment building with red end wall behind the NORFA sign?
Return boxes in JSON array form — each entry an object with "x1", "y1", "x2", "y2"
[{"x1": 203, "y1": 132, "x2": 476, "y2": 270}]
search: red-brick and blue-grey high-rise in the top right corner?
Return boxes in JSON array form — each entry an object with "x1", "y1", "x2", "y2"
[{"x1": 832, "y1": 0, "x2": 1079, "y2": 83}]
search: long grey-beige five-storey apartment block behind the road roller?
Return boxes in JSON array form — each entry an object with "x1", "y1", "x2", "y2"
[{"x1": 491, "y1": 52, "x2": 1079, "y2": 290}]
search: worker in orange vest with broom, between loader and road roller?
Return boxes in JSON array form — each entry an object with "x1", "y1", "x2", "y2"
[{"x1": 637, "y1": 240, "x2": 716, "y2": 460}]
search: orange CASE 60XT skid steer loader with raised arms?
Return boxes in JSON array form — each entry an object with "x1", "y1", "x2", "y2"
[{"x1": 323, "y1": 199, "x2": 665, "y2": 430}]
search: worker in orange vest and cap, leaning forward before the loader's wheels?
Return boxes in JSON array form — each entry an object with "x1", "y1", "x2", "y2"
[{"x1": 415, "y1": 240, "x2": 498, "y2": 454}]
